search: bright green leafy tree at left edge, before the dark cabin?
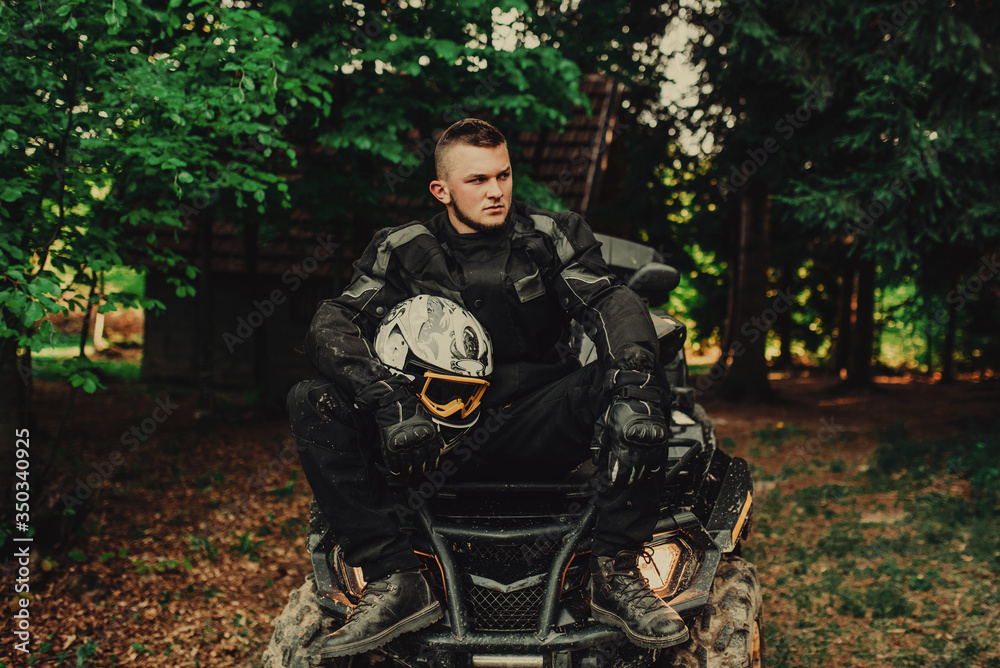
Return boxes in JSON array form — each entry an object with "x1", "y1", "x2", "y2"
[{"x1": 0, "y1": 0, "x2": 306, "y2": 516}]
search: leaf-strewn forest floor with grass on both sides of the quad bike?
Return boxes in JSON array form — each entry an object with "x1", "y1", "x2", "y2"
[{"x1": 0, "y1": 378, "x2": 1000, "y2": 668}]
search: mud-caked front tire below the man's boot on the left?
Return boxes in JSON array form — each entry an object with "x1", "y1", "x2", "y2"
[{"x1": 263, "y1": 573, "x2": 346, "y2": 668}]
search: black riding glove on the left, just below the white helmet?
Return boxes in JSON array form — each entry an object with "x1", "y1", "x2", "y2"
[{"x1": 355, "y1": 376, "x2": 442, "y2": 476}]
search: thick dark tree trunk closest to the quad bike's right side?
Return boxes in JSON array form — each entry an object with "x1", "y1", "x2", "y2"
[{"x1": 720, "y1": 183, "x2": 774, "y2": 402}]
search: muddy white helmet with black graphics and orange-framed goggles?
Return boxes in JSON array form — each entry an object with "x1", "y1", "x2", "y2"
[{"x1": 375, "y1": 295, "x2": 493, "y2": 436}]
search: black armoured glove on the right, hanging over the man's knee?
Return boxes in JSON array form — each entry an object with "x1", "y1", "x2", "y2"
[{"x1": 590, "y1": 370, "x2": 669, "y2": 488}]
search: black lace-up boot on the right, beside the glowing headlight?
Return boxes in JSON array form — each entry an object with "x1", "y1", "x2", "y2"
[{"x1": 590, "y1": 551, "x2": 688, "y2": 649}]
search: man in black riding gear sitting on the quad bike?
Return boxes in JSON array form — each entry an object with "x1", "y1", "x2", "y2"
[{"x1": 288, "y1": 119, "x2": 688, "y2": 656}]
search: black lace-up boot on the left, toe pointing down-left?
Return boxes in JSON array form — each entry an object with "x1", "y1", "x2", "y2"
[{"x1": 320, "y1": 571, "x2": 443, "y2": 659}]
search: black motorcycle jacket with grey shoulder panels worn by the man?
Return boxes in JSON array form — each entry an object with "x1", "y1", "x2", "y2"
[{"x1": 305, "y1": 202, "x2": 658, "y2": 406}]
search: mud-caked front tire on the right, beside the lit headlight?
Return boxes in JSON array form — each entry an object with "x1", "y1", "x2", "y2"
[{"x1": 656, "y1": 555, "x2": 764, "y2": 668}]
